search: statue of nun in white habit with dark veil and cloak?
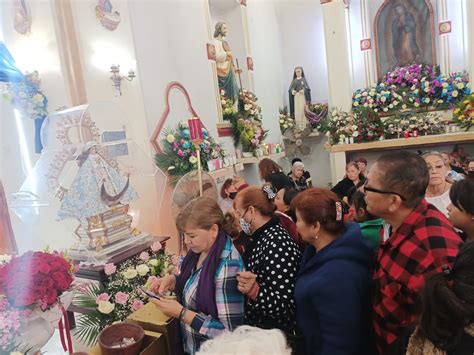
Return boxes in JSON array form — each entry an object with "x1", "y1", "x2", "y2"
[{"x1": 288, "y1": 67, "x2": 311, "y2": 131}]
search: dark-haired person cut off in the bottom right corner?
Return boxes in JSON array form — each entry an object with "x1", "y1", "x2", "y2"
[{"x1": 406, "y1": 242, "x2": 474, "y2": 355}]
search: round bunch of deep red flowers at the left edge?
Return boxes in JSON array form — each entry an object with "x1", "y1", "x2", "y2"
[{"x1": 0, "y1": 251, "x2": 75, "y2": 311}]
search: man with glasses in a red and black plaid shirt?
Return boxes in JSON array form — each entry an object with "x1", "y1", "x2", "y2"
[{"x1": 363, "y1": 151, "x2": 462, "y2": 354}]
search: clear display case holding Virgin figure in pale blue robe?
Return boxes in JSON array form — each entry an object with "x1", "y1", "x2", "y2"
[{"x1": 9, "y1": 102, "x2": 167, "y2": 264}]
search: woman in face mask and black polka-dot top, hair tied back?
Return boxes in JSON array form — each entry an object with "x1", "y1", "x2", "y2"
[{"x1": 234, "y1": 185, "x2": 301, "y2": 350}]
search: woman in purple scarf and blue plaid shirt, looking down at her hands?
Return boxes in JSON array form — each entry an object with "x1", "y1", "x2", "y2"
[{"x1": 153, "y1": 197, "x2": 244, "y2": 354}]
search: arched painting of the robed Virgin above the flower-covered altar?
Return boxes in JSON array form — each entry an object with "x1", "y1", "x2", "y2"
[{"x1": 374, "y1": 0, "x2": 436, "y2": 79}]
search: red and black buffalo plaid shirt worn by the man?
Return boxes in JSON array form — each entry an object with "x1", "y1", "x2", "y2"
[{"x1": 373, "y1": 200, "x2": 462, "y2": 354}]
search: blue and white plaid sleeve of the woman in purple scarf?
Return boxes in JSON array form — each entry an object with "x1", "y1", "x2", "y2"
[{"x1": 191, "y1": 248, "x2": 244, "y2": 338}]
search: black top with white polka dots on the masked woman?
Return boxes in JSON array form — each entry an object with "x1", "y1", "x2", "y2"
[{"x1": 244, "y1": 218, "x2": 301, "y2": 332}]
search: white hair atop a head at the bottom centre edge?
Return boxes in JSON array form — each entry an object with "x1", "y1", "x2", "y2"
[{"x1": 197, "y1": 325, "x2": 291, "y2": 355}]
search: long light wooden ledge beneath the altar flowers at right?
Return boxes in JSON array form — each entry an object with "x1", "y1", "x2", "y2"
[{"x1": 327, "y1": 131, "x2": 474, "y2": 153}]
